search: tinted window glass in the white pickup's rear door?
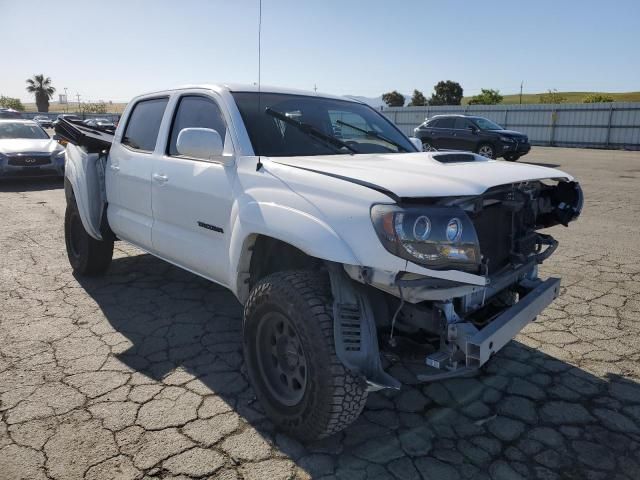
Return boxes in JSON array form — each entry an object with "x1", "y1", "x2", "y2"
[{"x1": 121, "y1": 97, "x2": 169, "y2": 153}]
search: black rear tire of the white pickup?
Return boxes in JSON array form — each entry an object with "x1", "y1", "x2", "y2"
[{"x1": 64, "y1": 198, "x2": 113, "y2": 276}]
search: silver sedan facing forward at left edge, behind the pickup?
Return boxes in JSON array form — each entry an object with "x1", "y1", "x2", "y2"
[{"x1": 0, "y1": 119, "x2": 65, "y2": 178}]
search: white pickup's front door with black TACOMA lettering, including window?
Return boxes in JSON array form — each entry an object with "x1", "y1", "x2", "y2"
[{"x1": 151, "y1": 93, "x2": 235, "y2": 285}]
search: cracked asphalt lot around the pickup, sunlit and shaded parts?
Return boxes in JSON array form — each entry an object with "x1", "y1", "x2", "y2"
[{"x1": 0, "y1": 148, "x2": 640, "y2": 480}]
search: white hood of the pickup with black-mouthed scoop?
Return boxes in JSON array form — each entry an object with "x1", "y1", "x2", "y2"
[{"x1": 271, "y1": 152, "x2": 573, "y2": 198}]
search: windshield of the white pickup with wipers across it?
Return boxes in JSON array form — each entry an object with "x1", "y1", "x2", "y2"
[{"x1": 233, "y1": 92, "x2": 416, "y2": 157}]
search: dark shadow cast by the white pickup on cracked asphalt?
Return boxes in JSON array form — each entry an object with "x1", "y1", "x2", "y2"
[{"x1": 78, "y1": 255, "x2": 640, "y2": 480}]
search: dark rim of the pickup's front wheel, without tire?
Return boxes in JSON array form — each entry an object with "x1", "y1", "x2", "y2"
[{"x1": 255, "y1": 311, "x2": 308, "y2": 407}]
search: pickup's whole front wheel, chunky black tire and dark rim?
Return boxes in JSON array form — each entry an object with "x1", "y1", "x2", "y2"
[{"x1": 243, "y1": 271, "x2": 367, "y2": 441}]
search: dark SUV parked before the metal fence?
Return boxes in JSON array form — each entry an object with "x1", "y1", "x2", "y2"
[{"x1": 414, "y1": 115, "x2": 531, "y2": 162}]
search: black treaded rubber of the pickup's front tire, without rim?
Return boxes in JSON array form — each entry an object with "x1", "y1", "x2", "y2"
[{"x1": 243, "y1": 271, "x2": 367, "y2": 441}]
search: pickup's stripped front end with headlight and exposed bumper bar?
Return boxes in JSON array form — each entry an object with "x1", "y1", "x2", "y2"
[{"x1": 329, "y1": 179, "x2": 583, "y2": 390}]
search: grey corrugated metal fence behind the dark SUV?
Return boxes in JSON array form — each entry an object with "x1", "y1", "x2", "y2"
[{"x1": 382, "y1": 102, "x2": 640, "y2": 150}]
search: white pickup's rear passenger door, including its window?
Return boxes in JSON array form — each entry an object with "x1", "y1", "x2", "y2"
[{"x1": 107, "y1": 97, "x2": 169, "y2": 250}]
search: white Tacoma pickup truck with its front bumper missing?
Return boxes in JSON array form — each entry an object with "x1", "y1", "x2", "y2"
[{"x1": 57, "y1": 85, "x2": 583, "y2": 440}]
